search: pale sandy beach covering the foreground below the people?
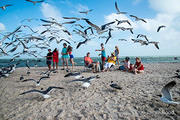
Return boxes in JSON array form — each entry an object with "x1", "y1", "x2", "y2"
[{"x1": 0, "y1": 63, "x2": 180, "y2": 120}]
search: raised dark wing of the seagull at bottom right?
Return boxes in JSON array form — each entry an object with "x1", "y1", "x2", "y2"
[{"x1": 161, "y1": 81, "x2": 176, "y2": 101}]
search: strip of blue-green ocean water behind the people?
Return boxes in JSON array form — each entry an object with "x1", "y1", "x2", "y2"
[{"x1": 0, "y1": 56, "x2": 180, "y2": 67}]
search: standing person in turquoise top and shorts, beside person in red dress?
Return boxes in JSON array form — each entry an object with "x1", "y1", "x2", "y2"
[{"x1": 61, "y1": 43, "x2": 68, "y2": 70}]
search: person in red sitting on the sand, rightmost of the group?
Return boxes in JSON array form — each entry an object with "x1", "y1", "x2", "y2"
[{"x1": 134, "y1": 57, "x2": 144, "y2": 74}]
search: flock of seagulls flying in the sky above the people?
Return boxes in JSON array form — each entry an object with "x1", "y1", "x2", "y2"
[{"x1": 0, "y1": 0, "x2": 166, "y2": 61}]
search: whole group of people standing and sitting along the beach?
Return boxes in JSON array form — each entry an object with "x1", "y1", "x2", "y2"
[{"x1": 46, "y1": 43, "x2": 144, "y2": 74}]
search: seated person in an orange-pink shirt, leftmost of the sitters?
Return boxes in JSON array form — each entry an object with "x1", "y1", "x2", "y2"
[{"x1": 84, "y1": 52, "x2": 99, "y2": 72}]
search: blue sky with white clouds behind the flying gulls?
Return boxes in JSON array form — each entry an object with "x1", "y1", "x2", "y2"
[{"x1": 0, "y1": 0, "x2": 180, "y2": 58}]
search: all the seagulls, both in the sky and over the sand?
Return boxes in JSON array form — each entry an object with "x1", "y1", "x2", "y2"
[{"x1": 0, "y1": 0, "x2": 180, "y2": 104}]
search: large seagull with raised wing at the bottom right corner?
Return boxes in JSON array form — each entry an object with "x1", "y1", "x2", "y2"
[{"x1": 160, "y1": 81, "x2": 180, "y2": 104}]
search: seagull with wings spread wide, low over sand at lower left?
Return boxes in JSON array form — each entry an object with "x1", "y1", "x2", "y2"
[{"x1": 19, "y1": 86, "x2": 64, "y2": 98}]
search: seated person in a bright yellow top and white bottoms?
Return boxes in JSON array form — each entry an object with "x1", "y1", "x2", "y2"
[{"x1": 103, "y1": 53, "x2": 116, "y2": 71}]
